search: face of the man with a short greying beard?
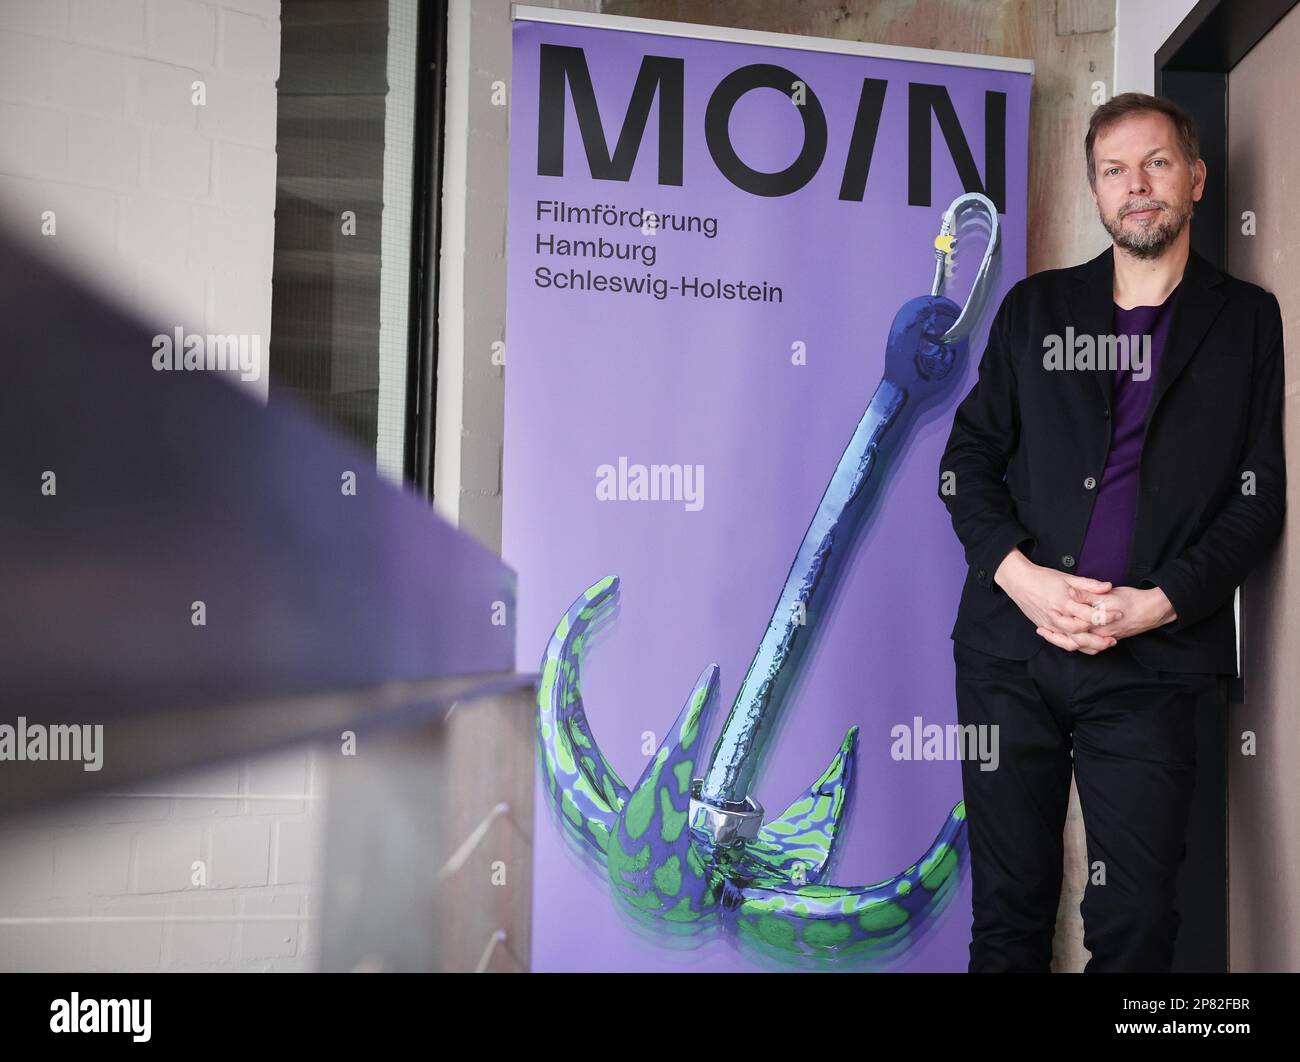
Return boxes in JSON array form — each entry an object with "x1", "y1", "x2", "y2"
[{"x1": 1092, "y1": 110, "x2": 1205, "y2": 259}]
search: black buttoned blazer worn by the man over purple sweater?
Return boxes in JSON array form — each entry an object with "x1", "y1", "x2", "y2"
[{"x1": 939, "y1": 241, "x2": 1286, "y2": 675}]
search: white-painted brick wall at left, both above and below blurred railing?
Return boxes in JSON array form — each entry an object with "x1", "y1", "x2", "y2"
[{"x1": 0, "y1": 0, "x2": 324, "y2": 970}]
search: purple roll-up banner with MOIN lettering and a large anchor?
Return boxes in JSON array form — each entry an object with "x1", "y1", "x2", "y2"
[{"x1": 502, "y1": 8, "x2": 1032, "y2": 971}]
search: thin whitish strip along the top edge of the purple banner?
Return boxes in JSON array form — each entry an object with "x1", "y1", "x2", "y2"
[{"x1": 510, "y1": 4, "x2": 1034, "y2": 74}]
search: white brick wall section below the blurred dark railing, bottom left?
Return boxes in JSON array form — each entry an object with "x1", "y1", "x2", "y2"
[{"x1": 0, "y1": 749, "x2": 325, "y2": 971}]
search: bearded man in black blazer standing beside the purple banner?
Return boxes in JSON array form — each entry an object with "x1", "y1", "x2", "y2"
[{"x1": 939, "y1": 92, "x2": 1286, "y2": 972}]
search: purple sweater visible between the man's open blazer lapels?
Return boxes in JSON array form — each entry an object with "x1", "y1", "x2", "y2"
[{"x1": 1075, "y1": 287, "x2": 1179, "y2": 586}]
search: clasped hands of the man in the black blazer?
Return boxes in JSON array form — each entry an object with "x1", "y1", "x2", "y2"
[{"x1": 993, "y1": 549, "x2": 1178, "y2": 656}]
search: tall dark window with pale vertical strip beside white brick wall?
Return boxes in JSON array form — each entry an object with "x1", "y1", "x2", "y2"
[{"x1": 269, "y1": 0, "x2": 446, "y2": 494}]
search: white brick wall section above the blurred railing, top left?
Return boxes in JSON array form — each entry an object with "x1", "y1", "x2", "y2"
[{"x1": 0, "y1": 0, "x2": 280, "y2": 399}]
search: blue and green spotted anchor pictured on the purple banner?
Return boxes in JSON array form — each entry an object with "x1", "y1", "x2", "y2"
[{"x1": 537, "y1": 192, "x2": 1000, "y2": 963}]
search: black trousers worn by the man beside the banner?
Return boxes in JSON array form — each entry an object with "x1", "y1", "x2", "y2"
[{"x1": 953, "y1": 640, "x2": 1222, "y2": 974}]
